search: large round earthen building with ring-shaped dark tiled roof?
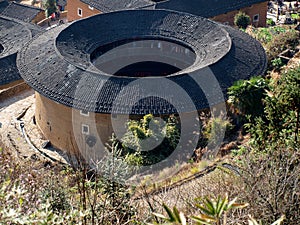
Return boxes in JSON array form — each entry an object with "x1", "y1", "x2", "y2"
[{"x1": 18, "y1": 10, "x2": 266, "y2": 159}]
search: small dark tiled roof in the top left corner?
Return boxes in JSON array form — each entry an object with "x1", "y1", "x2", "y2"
[{"x1": 1, "y1": 2, "x2": 43, "y2": 23}]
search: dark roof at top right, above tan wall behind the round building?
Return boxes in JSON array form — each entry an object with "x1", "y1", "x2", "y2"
[{"x1": 156, "y1": 0, "x2": 267, "y2": 18}]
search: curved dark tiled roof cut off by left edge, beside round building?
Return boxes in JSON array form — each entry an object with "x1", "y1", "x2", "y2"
[{"x1": 0, "y1": 16, "x2": 41, "y2": 85}]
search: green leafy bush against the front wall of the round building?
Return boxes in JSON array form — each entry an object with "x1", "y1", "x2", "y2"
[{"x1": 121, "y1": 114, "x2": 180, "y2": 165}]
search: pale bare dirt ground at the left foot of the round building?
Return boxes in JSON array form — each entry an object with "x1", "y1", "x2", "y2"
[{"x1": 0, "y1": 90, "x2": 67, "y2": 163}]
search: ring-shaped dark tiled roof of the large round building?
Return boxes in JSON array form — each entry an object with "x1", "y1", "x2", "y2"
[{"x1": 17, "y1": 10, "x2": 266, "y2": 114}]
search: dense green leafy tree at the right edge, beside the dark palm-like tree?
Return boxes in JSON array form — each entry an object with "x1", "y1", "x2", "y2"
[{"x1": 247, "y1": 67, "x2": 300, "y2": 146}]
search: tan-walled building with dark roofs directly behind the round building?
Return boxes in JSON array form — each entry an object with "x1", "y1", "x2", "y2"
[{"x1": 67, "y1": 0, "x2": 268, "y2": 27}]
